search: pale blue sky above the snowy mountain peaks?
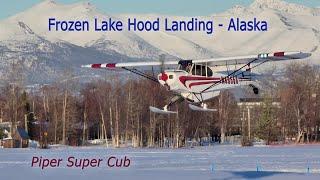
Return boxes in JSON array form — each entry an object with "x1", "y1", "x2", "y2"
[{"x1": 0, "y1": 0, "x2": 320, "y2": 19}]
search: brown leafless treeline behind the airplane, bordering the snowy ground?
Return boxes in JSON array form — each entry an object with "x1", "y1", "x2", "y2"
[{"x1": 0, "y1": 64, "x2": 320, "y2": 147}]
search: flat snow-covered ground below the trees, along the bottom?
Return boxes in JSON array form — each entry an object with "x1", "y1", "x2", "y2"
[{"x1": 0, "y1": 145, "x2": 320, "y2": 180}]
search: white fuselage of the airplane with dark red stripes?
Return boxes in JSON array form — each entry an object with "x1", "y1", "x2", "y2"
[{"x1": 157, "y1": 66, "x2": 255, "y2": 103}]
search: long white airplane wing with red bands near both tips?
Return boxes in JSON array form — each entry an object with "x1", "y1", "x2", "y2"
[{"x1": 82, "y1": 51, "x2": 311, "y2": 69}]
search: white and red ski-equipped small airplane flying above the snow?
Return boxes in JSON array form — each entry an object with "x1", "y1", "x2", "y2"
[{"x1": 82, "y1": 52, "x2": 311, "y2": 114}]
